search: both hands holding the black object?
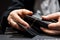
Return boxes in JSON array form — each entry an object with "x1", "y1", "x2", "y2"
[{"x1": 7, "y1": 9, "x2": 60, "y2": 35}]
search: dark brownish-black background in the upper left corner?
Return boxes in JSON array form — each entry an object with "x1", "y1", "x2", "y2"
[{"x1": 0, "y1": 0, "x2": 11, "y2": 20}]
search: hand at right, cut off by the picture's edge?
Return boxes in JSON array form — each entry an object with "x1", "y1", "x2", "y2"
[{"x1": 40, "y1": 12, "x2": 60, "y2": 35}]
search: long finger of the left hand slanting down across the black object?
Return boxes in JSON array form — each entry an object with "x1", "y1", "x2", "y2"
[{"x1": 12, "y1": 13, "x2": 30, "y2": 28}]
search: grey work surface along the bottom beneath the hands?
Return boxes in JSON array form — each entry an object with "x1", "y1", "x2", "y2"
[{"x1": 0, "y1": 34, "x2": 60, "y2": 40}]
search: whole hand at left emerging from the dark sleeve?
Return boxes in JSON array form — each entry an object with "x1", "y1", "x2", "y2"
[{"x1": 7, "y1": 9, "x2": 33, "y2": 30}]
